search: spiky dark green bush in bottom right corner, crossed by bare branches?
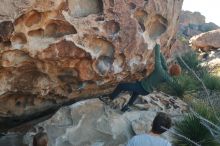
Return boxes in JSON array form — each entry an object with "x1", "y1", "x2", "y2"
[{"x1": 173, "y1": 102, "x2": 220, "y2": 146}]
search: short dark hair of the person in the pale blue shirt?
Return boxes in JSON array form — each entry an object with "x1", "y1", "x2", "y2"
[{"x1": 152, "y1": 112, "x2": 171, "y2": 134}]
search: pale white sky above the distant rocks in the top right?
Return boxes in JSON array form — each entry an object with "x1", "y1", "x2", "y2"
[{"x1": 183, "y1": 0, "x2": 220, "y2": 26}]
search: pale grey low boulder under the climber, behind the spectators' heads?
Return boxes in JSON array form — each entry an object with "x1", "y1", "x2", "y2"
[{"x1": 19, "y1": 93, "x2": 187, "y2": 146}]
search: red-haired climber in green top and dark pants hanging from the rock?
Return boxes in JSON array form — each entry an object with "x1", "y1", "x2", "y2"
[{"x1": 99, "y1": 40, "x2": 181, "y2": 112}]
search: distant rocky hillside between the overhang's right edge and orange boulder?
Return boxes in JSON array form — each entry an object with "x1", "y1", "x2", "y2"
[{"x1": 172, "y1": 11, "x2": 219, "y2": 54}]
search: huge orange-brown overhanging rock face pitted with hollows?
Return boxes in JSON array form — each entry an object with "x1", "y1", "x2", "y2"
[{"x1": 0, "y1": 0, "x2": 183, "y2": 122}]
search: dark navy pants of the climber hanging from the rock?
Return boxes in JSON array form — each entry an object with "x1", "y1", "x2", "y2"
[{"x1": 110, "y1": 82, "x2": 149, "y2": 106}]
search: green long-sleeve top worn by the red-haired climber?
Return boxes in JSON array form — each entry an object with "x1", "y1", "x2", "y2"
[{"x1": 141, "y1": 44, "x2": 177, "y2": 93}]
